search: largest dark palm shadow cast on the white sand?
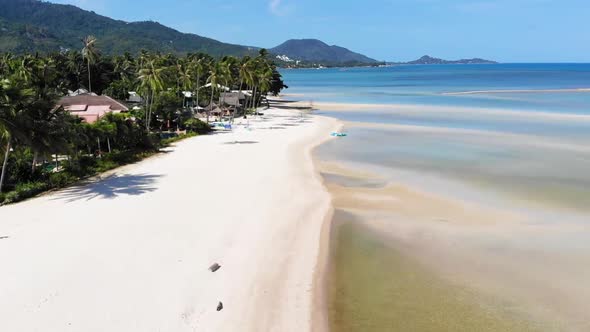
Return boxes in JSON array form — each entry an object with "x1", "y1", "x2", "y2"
[{"x1": 54, "y1": 174, "x2": 162, "y2": 203}]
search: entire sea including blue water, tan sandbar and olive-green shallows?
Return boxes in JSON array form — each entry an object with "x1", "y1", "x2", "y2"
[{"x1": 281, "y1": 64, "x2": 590, "y2": 331}]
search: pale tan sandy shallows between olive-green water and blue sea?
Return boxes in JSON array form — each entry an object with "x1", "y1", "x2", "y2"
[{"x1": 318, "y1": 113, "x2": 590, "y2": 331}]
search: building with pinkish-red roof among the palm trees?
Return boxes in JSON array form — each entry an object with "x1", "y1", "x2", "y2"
[{"x1": 58, "y1": 94, "x2": 129, "y2": 123}]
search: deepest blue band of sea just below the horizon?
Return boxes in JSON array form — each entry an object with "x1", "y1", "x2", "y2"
[{"x1": 282, "y1": 64, "x2": 590, "y2": 114}]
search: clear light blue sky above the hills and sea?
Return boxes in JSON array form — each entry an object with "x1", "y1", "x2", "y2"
[{"x1": 51, "y1": 0, "x2": 590, "y2": 62}]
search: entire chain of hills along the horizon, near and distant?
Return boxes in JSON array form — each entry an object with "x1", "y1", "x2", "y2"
[{"x1": 0, "y1": 0, "x2": 496, "y2": 67}]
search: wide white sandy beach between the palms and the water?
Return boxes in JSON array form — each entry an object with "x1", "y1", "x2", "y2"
[{"x1": 0, "y1": 110, "x2": 337, "y2": 332}]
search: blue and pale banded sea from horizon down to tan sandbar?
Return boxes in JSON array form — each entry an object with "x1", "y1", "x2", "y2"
[{"x1": 282, "y1": 64, "x2": 590, "y2": 208}]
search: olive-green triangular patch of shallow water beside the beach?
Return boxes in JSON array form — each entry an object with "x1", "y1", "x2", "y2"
[{"x1": 328, "y1": 212, "x2": 540, "y2": 332}]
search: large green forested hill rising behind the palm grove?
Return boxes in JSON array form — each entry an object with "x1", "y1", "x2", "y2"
[{"x1": 0, "y1": 0, "x2": 258, "y2": 56}]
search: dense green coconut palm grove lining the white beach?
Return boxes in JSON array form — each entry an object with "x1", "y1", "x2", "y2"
[{"x1": 0, "y1": 36, "x2": 286, "y2": 205}]
